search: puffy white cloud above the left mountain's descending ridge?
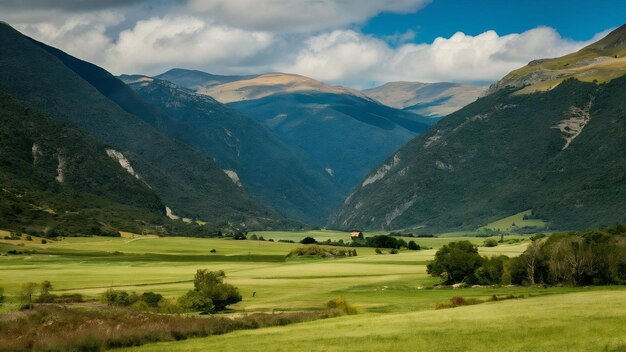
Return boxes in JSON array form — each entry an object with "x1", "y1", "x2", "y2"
[{"x1": 104, "y1": 17, "x2": 273, "y2": 74}]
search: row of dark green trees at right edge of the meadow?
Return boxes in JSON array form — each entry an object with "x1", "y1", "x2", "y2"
[{"x1": 427, "y1": 225, "x2": 626, "y2": 286}]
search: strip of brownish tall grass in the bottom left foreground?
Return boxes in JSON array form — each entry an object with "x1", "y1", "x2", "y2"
[{"x1": 0, "y1": 305, "x2": 332, "y2": 351}]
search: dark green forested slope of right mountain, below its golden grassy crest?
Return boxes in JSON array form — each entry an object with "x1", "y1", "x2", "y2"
[{"x1": 331, "y1": 27, "x2": 626, "y2": 232}]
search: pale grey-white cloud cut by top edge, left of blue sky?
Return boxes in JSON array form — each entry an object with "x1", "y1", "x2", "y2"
[{"x1": 188, "y1": 0, "x2": 430, "y2": 32}]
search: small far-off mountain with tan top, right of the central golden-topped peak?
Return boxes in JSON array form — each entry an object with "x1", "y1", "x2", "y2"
[{"x1": 363, "y1": 82, "x2": 485, "y2": 117}]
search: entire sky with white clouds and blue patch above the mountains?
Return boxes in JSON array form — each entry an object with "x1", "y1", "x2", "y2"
[{"x1": 0, "y1": 0, "x2": 626, "y2": 88}]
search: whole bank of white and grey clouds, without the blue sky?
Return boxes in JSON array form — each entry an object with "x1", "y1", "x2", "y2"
[{"x1": 0, "y1": 0, "x2": 606, "y2": 88}]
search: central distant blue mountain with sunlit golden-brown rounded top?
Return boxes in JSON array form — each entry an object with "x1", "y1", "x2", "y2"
[{"x1": 166, "y1": 71, "x2": 436, "y2": 197}]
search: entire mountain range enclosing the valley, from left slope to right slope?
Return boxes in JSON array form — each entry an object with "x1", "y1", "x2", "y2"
[{"x1": 0, "y1": 19, "x2": 626, "y2": 235}]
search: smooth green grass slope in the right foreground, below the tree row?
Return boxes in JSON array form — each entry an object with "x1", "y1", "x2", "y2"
[{"x1": 124, "y1": 290, "x2": 626, "y2": 352}]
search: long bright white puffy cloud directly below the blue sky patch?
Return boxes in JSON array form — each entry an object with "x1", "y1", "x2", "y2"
[{"x1": 289, "y1": 27, "x2": 600, "y2": 86}]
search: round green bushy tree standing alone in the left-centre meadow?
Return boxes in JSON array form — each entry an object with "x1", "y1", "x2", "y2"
[{"x1": 179, "y1": 269, "x2": 241, "y2": 312}]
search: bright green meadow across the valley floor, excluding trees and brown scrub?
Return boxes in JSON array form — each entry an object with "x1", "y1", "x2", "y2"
[{"x1": 0, "y1": 231, "x2": 626, "y2": 351}]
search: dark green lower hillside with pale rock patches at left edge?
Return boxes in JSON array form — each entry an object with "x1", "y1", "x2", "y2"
[{"x1": 0, "y1": 93, "x2": 165, "y2": 235}]
